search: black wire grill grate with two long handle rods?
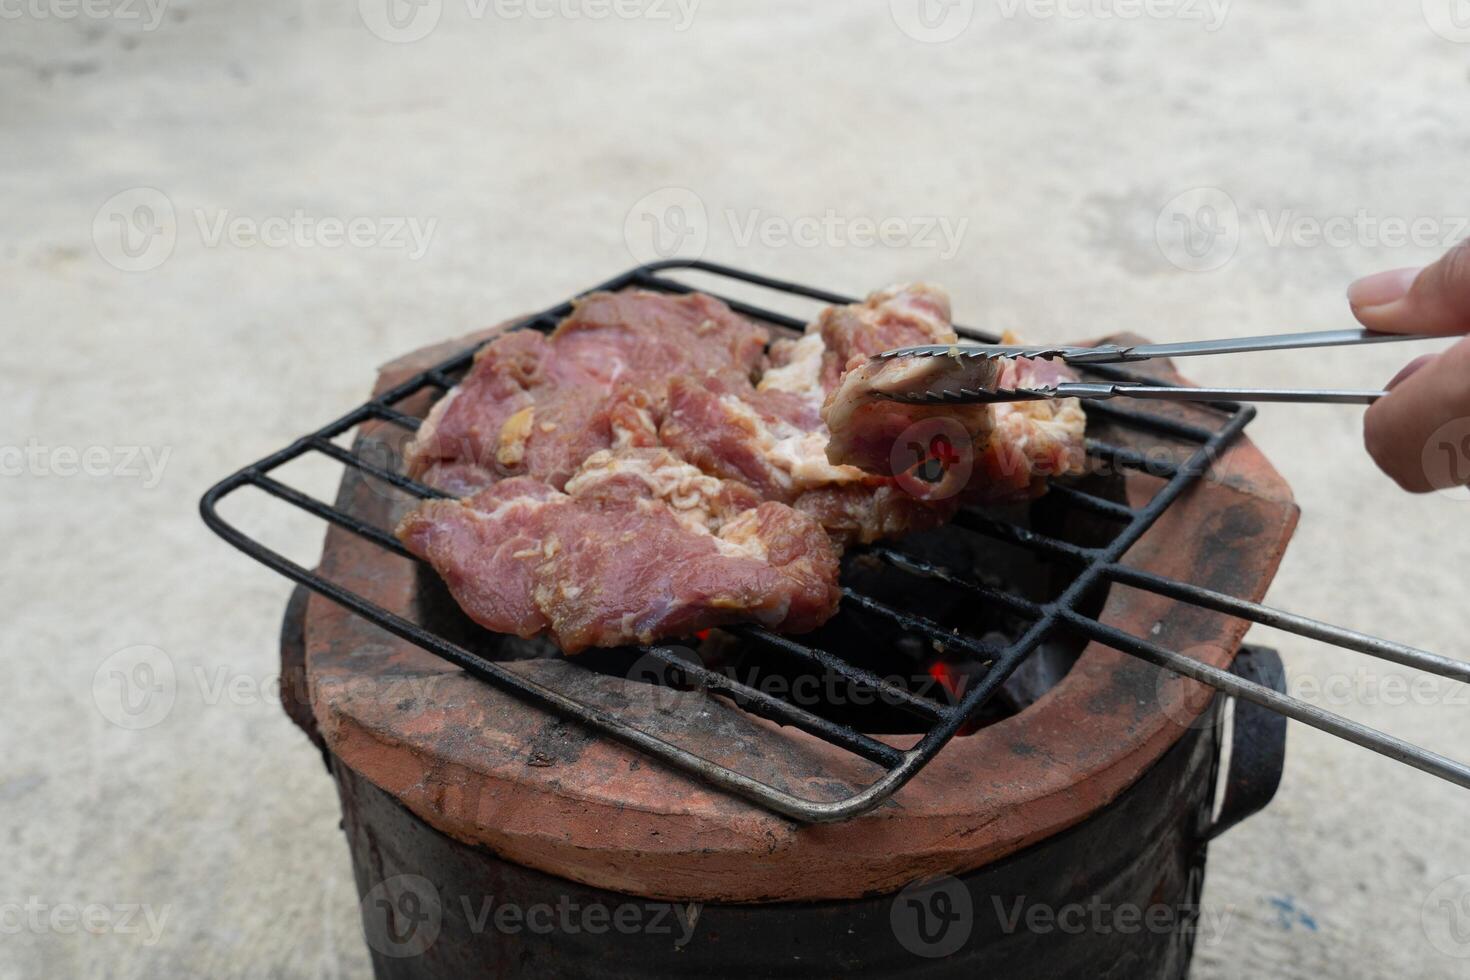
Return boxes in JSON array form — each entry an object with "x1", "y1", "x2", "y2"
[{"x1": 200, "y1": 260, "x2": 1470, "y2": 821}]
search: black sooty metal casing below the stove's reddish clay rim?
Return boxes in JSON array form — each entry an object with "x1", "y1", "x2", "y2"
[{"x1": 284, "y1": 595, "x2": 1285, "y2": 980}]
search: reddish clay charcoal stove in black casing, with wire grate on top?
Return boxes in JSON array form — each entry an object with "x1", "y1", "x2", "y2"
[{"x1": 203, "y1": 262, "x2": 1470, "y2": 977}]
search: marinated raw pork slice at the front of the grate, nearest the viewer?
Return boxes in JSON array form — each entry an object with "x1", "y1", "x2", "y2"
[{"x1": 397, "y1": 450, "x2": 839, "y2": 654}]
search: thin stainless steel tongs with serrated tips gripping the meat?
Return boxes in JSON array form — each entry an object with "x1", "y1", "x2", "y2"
[{"x1": 873, "y1": 331, "x2": 1432, "y2": 406}]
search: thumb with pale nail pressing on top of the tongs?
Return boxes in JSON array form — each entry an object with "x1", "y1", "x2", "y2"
[{"x1": 1348, "y1": 241, "x2": 1470, "y2": 334}]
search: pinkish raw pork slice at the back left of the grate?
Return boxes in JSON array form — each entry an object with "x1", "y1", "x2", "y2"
[{"x1": 404, "y1": 289, "x2": 767, "y2": 494}]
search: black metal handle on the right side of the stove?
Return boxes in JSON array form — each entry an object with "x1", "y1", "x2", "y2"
[{"x1": 1204, "y1": 646, "x2": 1286, "y2": 840}]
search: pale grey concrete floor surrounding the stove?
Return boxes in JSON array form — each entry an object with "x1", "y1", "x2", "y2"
[{"x1": 0, "y1": 0, "x2": 1470, "y2": 979}]
